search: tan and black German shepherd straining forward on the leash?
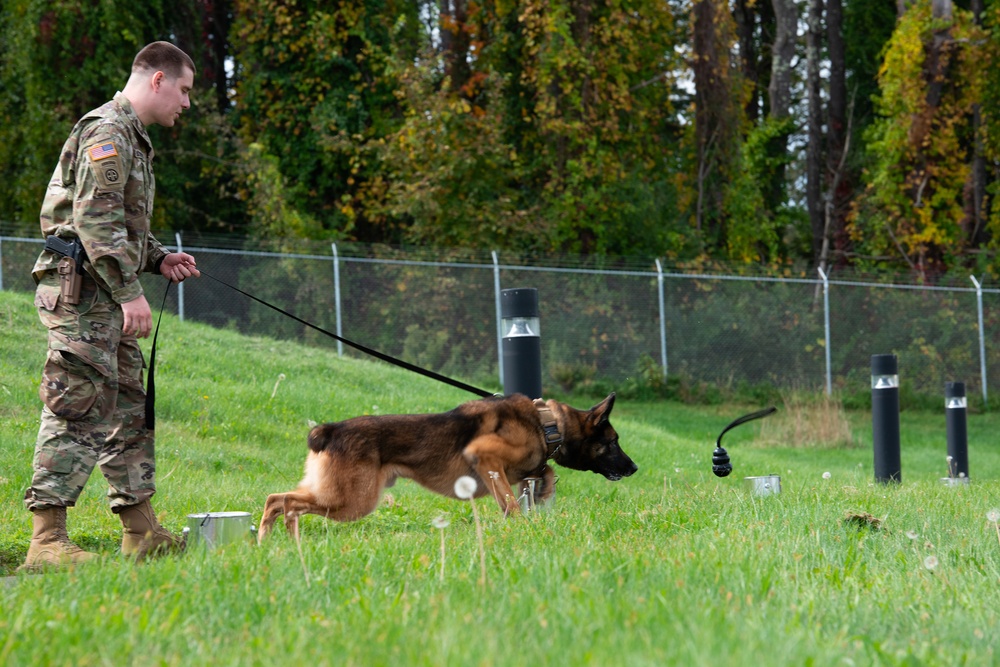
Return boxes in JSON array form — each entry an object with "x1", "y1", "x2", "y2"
[{"x1": 257, "y1": 394, "x2": 638, "y2": 541}]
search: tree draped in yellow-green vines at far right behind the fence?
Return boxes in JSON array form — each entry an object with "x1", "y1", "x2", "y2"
[{"x1": 851, "y1": 3, "x2": 983, "y2": 274}]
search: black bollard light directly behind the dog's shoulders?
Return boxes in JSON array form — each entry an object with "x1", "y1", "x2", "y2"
[{"x1": 500, "y1": 287, "x2": 542, "y2": 398}]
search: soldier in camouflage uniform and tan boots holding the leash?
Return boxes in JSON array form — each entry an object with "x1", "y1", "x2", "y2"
[{"x1": 20, "y1": 42, "x2": 200, "y2": 571}]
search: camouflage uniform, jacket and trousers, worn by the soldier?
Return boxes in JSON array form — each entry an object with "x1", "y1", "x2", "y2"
[{"x1": 24, "y1": 93, "x2": 168, "y2": 512}]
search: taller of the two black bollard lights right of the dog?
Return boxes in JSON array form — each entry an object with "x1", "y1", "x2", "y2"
[{"x1": 872, "y1": 354, "x2": 903, "y2": 482}]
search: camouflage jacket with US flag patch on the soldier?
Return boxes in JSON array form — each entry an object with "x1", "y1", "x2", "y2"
[{"x1": 32, "y1": 93, "x2": 169, "y2": 303}]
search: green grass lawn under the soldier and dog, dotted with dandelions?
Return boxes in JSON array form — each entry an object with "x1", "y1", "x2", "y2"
[{"x1": 0, "y1": 292, "x2": 1000, "y2": 666}]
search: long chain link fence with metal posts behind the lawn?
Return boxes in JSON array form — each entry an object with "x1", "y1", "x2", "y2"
[{"x1": 0, "y1": 234, "x2": 1000, "y2": 402}]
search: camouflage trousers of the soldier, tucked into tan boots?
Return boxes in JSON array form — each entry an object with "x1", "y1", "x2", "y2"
[{"x1": 24, "y1": 271, "x2": 155, "y2": 512}]
